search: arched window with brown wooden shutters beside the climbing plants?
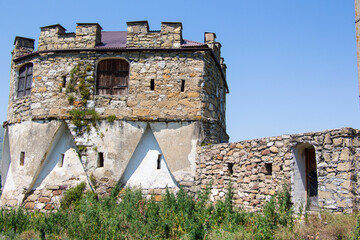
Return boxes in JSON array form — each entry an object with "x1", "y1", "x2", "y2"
[{"x1": 96, "y1": 59, "x2": 129, "y2": 95}]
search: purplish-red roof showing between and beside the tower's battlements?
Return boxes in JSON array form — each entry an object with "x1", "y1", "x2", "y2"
[{"x1": 96, "y1": 31, "x2": 205, "y2": 49}]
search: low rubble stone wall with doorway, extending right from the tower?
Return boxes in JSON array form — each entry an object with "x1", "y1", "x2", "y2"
[{"x1": 197, "y1": 128, "x2": 360, "y2": 212}]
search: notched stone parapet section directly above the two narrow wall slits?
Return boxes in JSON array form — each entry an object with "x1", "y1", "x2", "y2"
[{"x1": 126, "y1": 21, "x2": 183, "y2": 48}]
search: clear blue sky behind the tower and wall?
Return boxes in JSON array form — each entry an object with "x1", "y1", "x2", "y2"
[{"x1": 0, "y1": 0, "x2": 360, "y2": 141}]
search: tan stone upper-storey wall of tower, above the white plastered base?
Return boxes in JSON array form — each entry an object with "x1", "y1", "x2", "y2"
[{"x1": 8, "y1": 52, "x2": 205, "y2": 122}]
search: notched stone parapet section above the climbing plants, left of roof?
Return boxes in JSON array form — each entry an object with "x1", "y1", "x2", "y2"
[{"x1": 38, "y1": 23, "x2": 102, "y2": 51}]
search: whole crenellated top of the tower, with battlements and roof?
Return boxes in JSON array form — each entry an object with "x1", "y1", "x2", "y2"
[{"x1": 13, "y1": 21, "x2": 228, "y2": 87}]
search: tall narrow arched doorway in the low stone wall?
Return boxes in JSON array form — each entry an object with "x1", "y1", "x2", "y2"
[{"x1": 293, "y1": 143, "x2": 319, "y2": 209}]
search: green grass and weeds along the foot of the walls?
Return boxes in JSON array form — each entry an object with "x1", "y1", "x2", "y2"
[{"x1": 0, "y1": 184, "x2": 360, "y2": 239}]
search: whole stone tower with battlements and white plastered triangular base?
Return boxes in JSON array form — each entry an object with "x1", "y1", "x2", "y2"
[{"x1": 1, "y1": 21, "x2": 228, "y2": 209}]
